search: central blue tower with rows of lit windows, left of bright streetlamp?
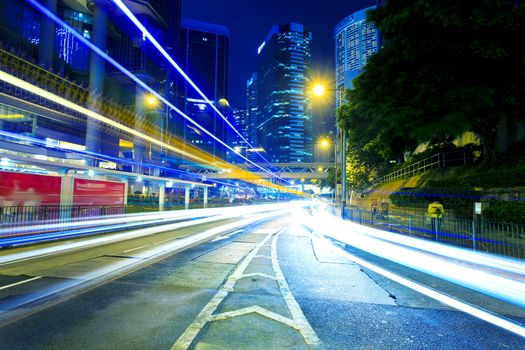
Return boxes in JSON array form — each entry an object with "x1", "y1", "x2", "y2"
[{"x1": 257, "y1": 23, "x2": 312, "y2": 163}]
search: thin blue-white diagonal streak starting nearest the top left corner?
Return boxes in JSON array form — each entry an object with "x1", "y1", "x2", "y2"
[{"x1": 26, "y1": 0, "x2": 289, "y2": 183}]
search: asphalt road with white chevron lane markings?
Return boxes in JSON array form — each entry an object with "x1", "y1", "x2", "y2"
[{"x1": 0, "y1": 209, "x2": 525, "y2": 350}]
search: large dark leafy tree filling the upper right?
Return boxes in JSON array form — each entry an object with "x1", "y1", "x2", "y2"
[{"x1": 338, "y1": 0, "x2": 525, "y2": 161}]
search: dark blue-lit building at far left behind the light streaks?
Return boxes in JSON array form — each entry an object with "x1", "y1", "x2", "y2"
[{"x1": 0, "y1": 0, "x2": 180, "y2": 166}]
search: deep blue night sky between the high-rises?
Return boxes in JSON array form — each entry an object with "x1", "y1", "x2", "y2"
[{"x1": 182, "y1": 0, "x2": 375, "y2": 136}]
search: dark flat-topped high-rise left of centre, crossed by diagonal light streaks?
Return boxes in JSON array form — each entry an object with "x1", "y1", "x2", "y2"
[{"x1": 181, "y1": 19, "x2": 230, "y2": 158}]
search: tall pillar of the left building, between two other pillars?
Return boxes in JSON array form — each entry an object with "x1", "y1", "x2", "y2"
[{"x1": 86, "y1": 2, "x2": 108, "y2": 166}]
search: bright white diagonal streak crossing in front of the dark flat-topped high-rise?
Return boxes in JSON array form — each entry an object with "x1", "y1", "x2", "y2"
[{"x1": 108, "y1": 0, "x2": 269, "y2": 163}]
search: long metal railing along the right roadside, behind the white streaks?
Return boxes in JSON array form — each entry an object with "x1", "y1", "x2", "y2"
[{"x1": 345, "y1": 208, "x2": 525, "y2": 259}]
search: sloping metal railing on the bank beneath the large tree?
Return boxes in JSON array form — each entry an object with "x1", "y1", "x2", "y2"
[{"x1": 375, "y1": 150, "x2": 474, "y2": 184}]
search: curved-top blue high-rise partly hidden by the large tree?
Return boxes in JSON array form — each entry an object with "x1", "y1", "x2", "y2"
[{"x1": 334, "y1": 6, "x2": 379, "y2": 107}]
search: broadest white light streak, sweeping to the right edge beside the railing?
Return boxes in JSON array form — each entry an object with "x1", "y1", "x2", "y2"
[{"x1": 301, "y1": 208, "x2": 525, "y2": 307}]
